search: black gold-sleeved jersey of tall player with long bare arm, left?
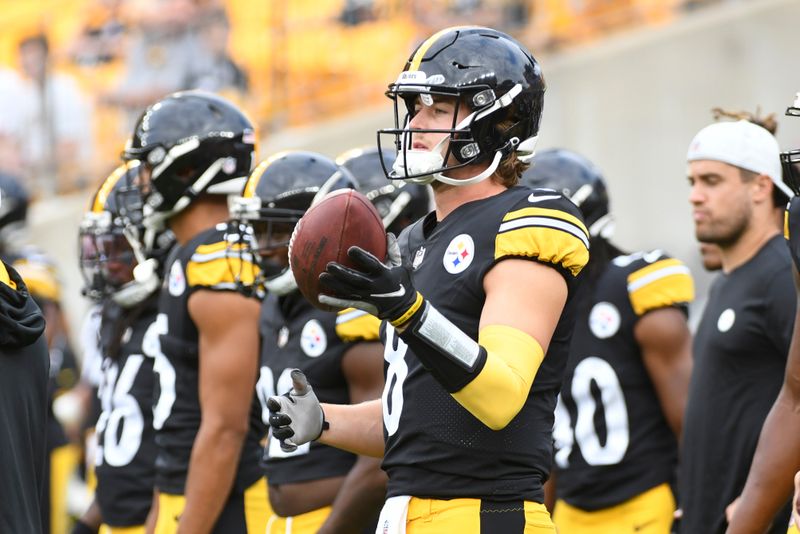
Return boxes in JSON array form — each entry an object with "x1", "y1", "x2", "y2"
[{"x1": 155, "y1": 224, "x2": 266, "y2": 494}]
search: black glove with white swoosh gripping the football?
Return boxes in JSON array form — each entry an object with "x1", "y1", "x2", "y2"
[{"x1": 319, "y1": 234, "x2": 422, "y2": 323}]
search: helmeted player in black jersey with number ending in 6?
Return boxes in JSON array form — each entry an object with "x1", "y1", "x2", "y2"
[{"x1": 73, "y1": 161, "x2": 169, "y2": 534}]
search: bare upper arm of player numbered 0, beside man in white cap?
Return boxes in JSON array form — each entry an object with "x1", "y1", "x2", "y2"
[{"x1": 633, "y1": 307, "x2": 692, "y2": 439}]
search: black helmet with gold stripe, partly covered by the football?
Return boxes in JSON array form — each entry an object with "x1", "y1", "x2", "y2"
[{"x1": 229, "y1": 151, "x2": 358, "y2": 295}]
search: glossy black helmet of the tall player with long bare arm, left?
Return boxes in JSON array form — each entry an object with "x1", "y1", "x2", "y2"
[{"x1": 123, "y1": 91, "x2": 256, "y2": 236}]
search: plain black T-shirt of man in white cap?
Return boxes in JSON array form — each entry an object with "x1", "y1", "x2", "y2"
[{"x1": 679, "y1": 236, "x2": 795, "y2": 534}]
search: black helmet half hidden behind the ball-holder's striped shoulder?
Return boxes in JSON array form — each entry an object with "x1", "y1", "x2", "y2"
[{"x1": 522, "y1": 148, "x2": 614, "y2": 239}]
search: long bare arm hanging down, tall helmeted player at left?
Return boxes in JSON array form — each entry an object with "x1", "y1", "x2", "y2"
[{"x1": 178, "y1": 290, "x2": 258, "y2": 534}]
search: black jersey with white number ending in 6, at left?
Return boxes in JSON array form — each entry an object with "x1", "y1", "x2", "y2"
[{"x1": 95, "y1": 298, "x2": 157, "y2": 527}]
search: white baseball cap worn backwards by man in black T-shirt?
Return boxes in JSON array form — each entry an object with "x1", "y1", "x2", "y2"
[{"x1": 686, "y1": 120, "x2": 794, "y2": 198}]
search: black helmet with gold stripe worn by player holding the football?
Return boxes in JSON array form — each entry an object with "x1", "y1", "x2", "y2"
[{"x1": 378, "y1": 26, "x2": 545, "y2": 185}]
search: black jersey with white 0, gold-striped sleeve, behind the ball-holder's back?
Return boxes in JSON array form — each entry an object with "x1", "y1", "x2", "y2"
[{"x1": 553, "y1": 250, "x2": 694, "y2": 510}]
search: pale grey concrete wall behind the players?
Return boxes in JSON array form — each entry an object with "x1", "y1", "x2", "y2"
[{"x1": 32, "y1": 0, "x2": 800, "y2": 356}]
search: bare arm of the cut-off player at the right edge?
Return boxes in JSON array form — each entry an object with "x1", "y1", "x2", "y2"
[{"x1": 728, "y1": 269, "x2": 800, "y2": 534}]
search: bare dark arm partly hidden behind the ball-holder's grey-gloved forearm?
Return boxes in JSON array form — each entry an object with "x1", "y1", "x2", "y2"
[{"x1": 319, "y1": 342, "x2": 387, "y2": 533}]
